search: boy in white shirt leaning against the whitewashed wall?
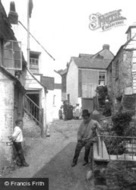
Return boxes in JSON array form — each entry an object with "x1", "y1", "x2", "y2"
[{"x1": 9, "y1": 119, "x2": 29, "y2": 167}]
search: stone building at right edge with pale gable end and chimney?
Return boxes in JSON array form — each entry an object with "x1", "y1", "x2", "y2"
[{"x1": 107, "y1": 26, "x2": 136, "y2": 111}]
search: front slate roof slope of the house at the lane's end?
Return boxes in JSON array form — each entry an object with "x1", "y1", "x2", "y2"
[{"x1": 73, "y1": 57, "x2": 111, "y2": 69}]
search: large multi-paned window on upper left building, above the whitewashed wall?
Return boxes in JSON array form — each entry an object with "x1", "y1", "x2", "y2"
[{"x1": 3, "y1": 40, "x2": 22, "y2": 70}]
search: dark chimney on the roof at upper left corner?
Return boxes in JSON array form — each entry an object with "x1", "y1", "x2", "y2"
[{"x1": 8, "y1": 1, "x2": 18, "y2": 24}]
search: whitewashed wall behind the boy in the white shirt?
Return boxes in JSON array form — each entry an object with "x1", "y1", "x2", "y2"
[{"x1": 0, "y1": 72, "x2": 14, "y2": 167}]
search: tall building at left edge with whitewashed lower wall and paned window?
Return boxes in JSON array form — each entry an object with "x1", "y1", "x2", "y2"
[{"x1": 0, "y1": 1, "x2": 26, "y2": 168}]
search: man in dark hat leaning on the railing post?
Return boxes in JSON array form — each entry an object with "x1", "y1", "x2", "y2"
[{"x1": 71, "y1": 109, "x2": 102, "y2": 167}]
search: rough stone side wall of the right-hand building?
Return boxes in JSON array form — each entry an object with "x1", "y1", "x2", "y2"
[{"x1": 108, "y1": 49, "x2": 133, "y2": 111}]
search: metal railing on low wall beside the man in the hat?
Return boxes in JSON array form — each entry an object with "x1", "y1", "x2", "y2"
[{"x1": 94, "y1": 135, "x2": 136, "y2": 161}]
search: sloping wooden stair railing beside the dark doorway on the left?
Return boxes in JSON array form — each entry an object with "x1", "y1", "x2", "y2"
[{"x1": 24, "y1": 95, "x2": 43, "y2": 129}]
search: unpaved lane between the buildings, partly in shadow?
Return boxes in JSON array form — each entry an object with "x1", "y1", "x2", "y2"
[{"x1": 1, "y1": 120, "x2": 96, "y2": 190}]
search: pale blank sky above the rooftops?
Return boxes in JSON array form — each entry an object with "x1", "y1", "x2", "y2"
[{"x1": 1, "y1": 0, "x2": 136, "y2": 69}]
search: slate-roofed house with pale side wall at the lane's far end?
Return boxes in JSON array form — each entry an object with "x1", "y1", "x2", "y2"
[{"x1": 66, "y1": 44, "x2": 113, "y2": 111}]
